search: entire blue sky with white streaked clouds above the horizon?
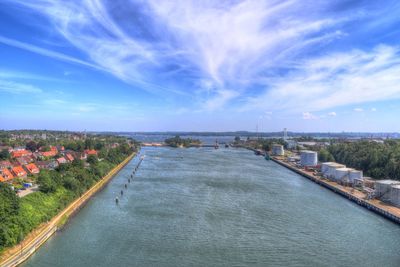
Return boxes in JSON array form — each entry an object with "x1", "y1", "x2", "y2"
[{"x1": 0, "y1": 0, "x2": 400, "y2": 132}]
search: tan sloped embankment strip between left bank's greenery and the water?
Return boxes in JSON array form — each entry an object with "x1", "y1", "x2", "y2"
[{"x1": 0, "y1": 153, "x2": 136, "y2": 267}]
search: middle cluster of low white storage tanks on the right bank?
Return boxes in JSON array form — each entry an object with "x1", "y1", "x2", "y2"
[{"x1": 321, "y1": 162, "x2": 363, "y2": 183}]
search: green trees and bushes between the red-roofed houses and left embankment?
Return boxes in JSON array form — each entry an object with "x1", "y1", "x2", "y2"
[{"x1": 0, "y1": 142, "x2": 132, "y2": 250}]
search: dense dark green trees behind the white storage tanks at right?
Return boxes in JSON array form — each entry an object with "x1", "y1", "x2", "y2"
[{"x1": 327, "y1": 140, "x2": 400, "y2": 180}]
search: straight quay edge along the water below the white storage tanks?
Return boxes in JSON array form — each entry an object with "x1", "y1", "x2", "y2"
[{"x1": 271, "y1": 157, "x2": 400, "y2": 224}]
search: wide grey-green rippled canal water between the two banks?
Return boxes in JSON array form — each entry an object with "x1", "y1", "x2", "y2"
[{"x1": 23, "y1": 148, "x2": 400, "y2": 267}]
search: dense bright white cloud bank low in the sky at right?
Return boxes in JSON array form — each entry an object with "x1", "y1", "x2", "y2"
[{"x1": 247, "y1": 46, "x2": 400, "y2": 111}]
